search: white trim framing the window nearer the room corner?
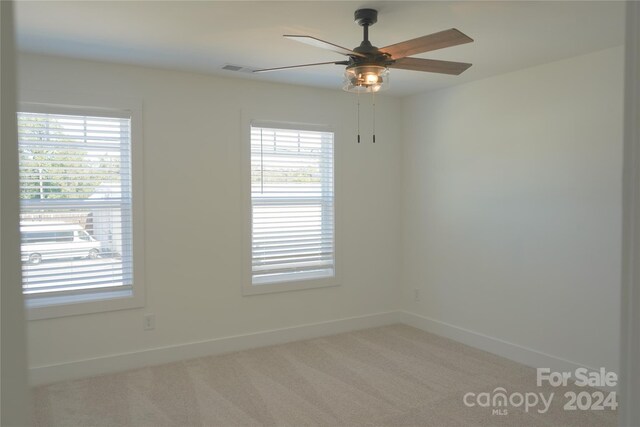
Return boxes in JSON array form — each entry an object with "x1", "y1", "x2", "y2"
[{"x1": 240, "y1": 111, "x2": 342, "y2": 296}]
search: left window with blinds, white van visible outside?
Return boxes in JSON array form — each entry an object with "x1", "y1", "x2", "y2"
[{"x1": 18, "y1": 105, "x2": 141, "y2": 318}]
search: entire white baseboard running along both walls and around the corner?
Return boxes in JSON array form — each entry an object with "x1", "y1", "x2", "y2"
[{"x1": 29, "y1": 311, "x2": 616, "y2": 392}]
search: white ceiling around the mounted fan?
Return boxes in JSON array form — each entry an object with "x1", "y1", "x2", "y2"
[{"x1": 15, "y1": 0, "x2": 624, "y2": 96}]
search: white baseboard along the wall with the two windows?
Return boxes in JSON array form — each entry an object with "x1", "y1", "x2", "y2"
[{"x1": 29, "y1": 311, "x2": 398, "y2": 386}]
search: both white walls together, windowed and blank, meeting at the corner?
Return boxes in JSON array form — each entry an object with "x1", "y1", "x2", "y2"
[{"x1": 19, "y1": 48, "x2": 623, "y2": 382}]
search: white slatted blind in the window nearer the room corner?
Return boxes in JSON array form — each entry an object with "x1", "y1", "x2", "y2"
[{"x1": 251, "y1": 126, "x2": 335, "y2": 285}]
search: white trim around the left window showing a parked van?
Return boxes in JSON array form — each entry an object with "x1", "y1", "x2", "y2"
[{"x1": 18, "y1": 91, "x2": 145, "y2": 320}]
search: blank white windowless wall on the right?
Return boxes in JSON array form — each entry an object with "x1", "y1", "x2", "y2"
[{"x1": 402, "y1": 48, "x2": 623, "y2": 370}]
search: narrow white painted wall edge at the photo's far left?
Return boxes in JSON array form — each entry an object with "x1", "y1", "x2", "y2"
[{"x1": 0, "y1": 1, "x2": 31, "y2": 426}]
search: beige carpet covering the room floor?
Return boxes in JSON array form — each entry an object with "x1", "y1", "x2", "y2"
[{"x1": 34, "y1": 325, "x2": 616, "y2": 427}]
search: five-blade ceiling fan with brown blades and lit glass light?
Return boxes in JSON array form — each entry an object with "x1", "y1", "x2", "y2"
[{"x1": 254, "y1": 9, "x2": 473, "y2": 92}]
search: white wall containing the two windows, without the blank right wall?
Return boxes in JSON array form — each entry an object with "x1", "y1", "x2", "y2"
[{"x1": 19, "y1": 51, "x2": 400, "y2": 382}]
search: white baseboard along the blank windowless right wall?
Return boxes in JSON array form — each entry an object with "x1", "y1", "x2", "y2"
[{"x1": 398, "y1": 311, "x2": 615, "y2": 390}]
